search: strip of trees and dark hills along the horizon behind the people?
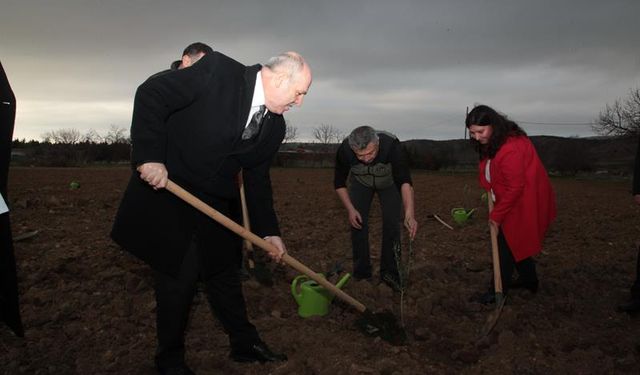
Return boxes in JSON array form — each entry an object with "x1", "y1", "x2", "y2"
[{"x1": 12, "y1": 88, "x2": 640, "y2": 174}]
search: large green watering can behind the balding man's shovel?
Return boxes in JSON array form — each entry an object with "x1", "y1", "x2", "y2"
[{"x1": 291, "y1": 273, "x2": 351, "y2": 318}]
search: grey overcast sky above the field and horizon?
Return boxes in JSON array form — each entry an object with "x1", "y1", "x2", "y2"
[{"x1": 0, "y1": 0, "x2": 640, "y2": 140}]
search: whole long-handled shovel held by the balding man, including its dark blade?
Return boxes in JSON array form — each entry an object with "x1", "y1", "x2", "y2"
[{"x1": 166, "y1": 180, "x2": 406, "y2": 345}]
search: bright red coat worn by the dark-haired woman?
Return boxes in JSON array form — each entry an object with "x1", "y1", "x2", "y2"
[{"x1": 480, "y1": 136, "x2": 556, "y2": 262}]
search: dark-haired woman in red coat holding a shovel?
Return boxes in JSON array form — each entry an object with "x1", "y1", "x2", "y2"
[{"x1": 465, "y1": 105, "x2": 556, "y2": 303}]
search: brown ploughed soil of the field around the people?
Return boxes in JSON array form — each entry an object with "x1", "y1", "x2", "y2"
[{"x1": 0, "y1": 167, "x2": 640, "y2": 374}]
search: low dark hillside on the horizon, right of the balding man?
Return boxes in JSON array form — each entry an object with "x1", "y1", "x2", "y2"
[{"x1": 276, "y1": 136, "x2": 637, "y2": 175}]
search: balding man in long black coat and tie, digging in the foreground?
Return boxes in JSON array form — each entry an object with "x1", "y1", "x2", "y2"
[{"x1": 111, "y1": 48, "x2": 311, "y2": 373}]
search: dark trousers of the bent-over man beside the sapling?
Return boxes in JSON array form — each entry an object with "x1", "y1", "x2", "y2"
[{"x1": 349, "y1": 179, "x2": 402, "y2": 277}]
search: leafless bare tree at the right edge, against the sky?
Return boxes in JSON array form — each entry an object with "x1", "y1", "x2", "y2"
[{"x1": 592, "y1": 88, "x2": 640, "y2": 136}]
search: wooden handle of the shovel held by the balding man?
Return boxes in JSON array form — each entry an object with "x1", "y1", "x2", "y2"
[{"x1": 166, "y1": 180, "x2": 367, "y2": 313}]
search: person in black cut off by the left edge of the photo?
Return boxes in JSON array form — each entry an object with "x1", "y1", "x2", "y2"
[{"x1": 0, "y1": 59, "x2": 24, "y2": 337}]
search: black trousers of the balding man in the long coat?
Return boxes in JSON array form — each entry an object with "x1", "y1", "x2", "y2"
[{"x1": 155, "y1": 233, "x2": 260, "y2": 368}]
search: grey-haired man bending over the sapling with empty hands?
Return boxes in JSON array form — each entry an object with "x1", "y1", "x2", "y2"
[{"x1": 334, "y1": 126, "x2": 418, "y2": 290}]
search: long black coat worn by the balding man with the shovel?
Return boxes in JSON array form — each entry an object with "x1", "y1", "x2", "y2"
[{"x1": 111, "y1": 52, "x2": 285, "y2": 274}]
